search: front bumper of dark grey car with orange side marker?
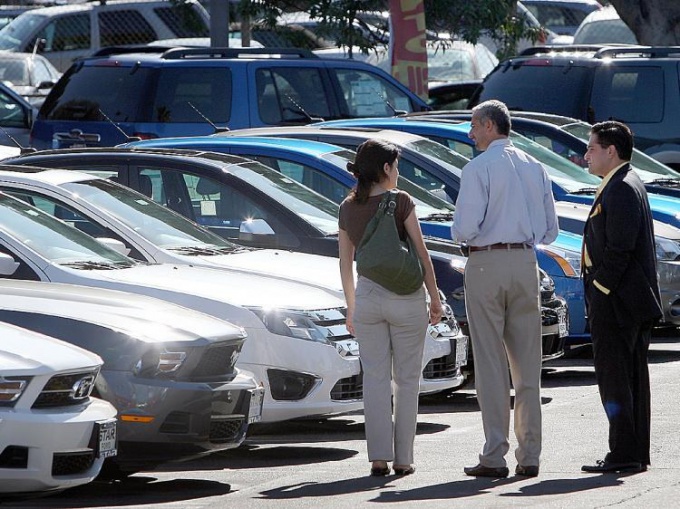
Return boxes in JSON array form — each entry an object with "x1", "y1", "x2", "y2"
[{"x1": 97, "y1": 371, "x2": 263, "y2": 470}]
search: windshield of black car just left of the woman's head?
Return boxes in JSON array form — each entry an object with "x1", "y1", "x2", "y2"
[{"x1": 234, "y1": 162, "x2": 339, "y2": 235}]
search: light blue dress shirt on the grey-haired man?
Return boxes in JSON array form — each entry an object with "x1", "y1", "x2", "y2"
[{"x1": 452, "y1": 138, "x2": 559, "y2": 246}]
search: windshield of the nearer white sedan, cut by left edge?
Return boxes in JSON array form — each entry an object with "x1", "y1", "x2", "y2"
[{"x1": 0, "y1": 193, "x2": 137, "y2": 268}]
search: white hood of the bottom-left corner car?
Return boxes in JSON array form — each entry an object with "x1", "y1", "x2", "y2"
[{"x1": 0, "y1": 323, "x2": 103, "y2": 376}]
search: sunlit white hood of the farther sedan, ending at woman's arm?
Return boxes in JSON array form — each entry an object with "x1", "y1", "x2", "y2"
[{"x1": 189, "y1": 249, "x2": 342, "y2": 292}]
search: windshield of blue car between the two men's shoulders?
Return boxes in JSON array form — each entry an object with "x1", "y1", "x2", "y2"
[{"x1": 510, "y1": 132, "x2": 601, "y2": 193}]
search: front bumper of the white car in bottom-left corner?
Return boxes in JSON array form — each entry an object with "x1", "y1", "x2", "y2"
[{"x1": 0, "y1": 398, "x2": 116, "y2": 493}]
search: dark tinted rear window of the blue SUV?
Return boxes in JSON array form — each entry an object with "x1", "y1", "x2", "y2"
[{"x1": 40, "y1": 67, "x2": 154, "y2": 122}]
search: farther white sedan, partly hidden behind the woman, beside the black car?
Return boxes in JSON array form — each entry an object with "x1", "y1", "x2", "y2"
[{"x1": 0, "y1": 170, "x2": 467, "y2": 393}]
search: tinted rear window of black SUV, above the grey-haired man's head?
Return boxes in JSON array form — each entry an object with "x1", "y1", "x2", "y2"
[{"x1": 471, "y1": 59, "x2": 593, "y2": 118}]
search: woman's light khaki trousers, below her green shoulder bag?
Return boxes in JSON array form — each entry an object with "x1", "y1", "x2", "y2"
[{"x1": 353, "y1": 277, "x2": 428, "y2": 465}]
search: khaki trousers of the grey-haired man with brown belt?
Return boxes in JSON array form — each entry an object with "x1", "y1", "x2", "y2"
[{"x1": 465, "y1": 249, "x2": 542, "y2": 468}]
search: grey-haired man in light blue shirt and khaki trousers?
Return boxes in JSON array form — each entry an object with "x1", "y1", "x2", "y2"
[{"x1": 452, "y1": 100, "x2": 558, "y2": 477}]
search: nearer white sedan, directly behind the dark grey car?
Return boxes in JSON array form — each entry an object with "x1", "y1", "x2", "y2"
[{"x1": 0, "y1": 189, "x2": 363, "y2": 422}]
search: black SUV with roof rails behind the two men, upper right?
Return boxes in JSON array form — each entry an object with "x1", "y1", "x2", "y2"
[{"x1": 470, "y1": 46, "x2": 680, "y2": 169}]
